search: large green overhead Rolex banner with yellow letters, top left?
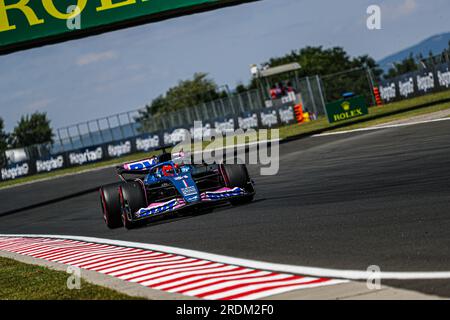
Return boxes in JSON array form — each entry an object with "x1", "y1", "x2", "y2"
[{"x1": 0, "y1": 0, "x2": 255, "y2": 54}]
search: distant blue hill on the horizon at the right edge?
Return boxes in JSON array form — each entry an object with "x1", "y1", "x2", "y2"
[{"x1": 378, "y1": 32, "x2": 450, "y2": 71}]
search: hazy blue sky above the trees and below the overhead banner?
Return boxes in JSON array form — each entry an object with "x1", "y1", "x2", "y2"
[{"x1": 0, "y1": 0, "x2": 450, "y2": 130}]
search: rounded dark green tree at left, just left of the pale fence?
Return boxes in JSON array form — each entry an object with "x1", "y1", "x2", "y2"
[{"x1": 10, "y1": 112, "x2": 54, "y2": 148}]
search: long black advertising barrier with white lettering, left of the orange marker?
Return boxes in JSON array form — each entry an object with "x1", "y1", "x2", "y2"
[{"x1": 0, "y1": 102, "x2": 302, "y2": 181}]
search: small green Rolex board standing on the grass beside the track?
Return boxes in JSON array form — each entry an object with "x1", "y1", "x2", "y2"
[{"x1": 326, "y1": 96, "x2": 369, "y2": 123}]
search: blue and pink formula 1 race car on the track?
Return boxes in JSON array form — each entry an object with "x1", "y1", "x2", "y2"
[{"x1": 100, "y1": 153, "x2": 255, "y2": 229}]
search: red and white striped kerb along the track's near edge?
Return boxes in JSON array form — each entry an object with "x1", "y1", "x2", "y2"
[{"x1": 0, "y1": 237, "x2": 339, "y2": 300}]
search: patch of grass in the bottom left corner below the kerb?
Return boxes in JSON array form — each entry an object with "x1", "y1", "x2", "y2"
[{"x1": 0, "y1": 258, "x2": 143, "y2": 300}]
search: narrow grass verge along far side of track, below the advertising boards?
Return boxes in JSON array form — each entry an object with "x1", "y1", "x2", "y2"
[{"x1": 0, "y1": 90, "x2": 450, "y2": 189}]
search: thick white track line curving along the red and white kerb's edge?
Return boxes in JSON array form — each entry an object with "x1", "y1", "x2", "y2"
[{"x1": 0, "y1": 234, "x2": 450, "y2": 280}]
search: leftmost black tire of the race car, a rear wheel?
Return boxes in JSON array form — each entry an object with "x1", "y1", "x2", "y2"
[{"x1": 99, "y1": 183, "x2": 123, "y2": 229}]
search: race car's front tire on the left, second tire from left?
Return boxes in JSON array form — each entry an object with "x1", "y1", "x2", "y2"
[{"x1": 119, "y1": 181, "x2": 147, "y2": 229}]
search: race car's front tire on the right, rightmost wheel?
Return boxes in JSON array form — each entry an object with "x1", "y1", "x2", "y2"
[{"x1": 222, "y1": 164, "x2": 255, "y2": 206}]
